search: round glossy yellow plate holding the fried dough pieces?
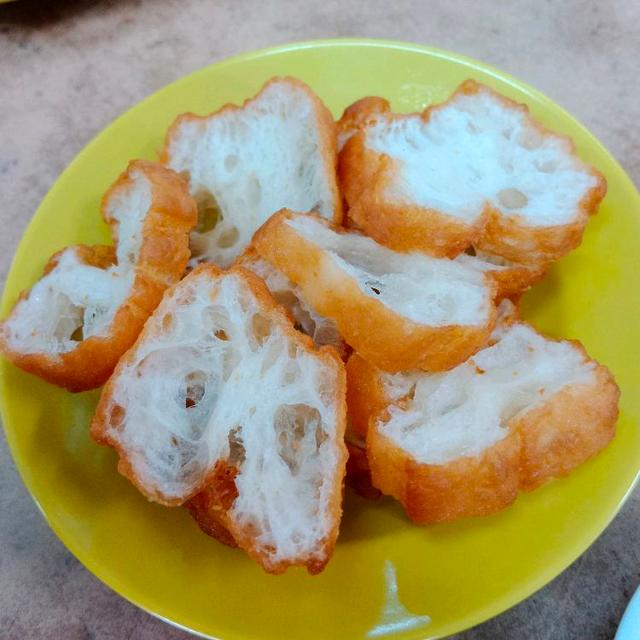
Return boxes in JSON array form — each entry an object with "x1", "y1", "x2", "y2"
[{"x1": 0, "y1": 40, "x2": 640, "y2": 640}]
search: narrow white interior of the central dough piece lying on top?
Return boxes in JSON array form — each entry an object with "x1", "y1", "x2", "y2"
[{"x1": 287, "y1": 216, "x2": 491, "y2": 326}]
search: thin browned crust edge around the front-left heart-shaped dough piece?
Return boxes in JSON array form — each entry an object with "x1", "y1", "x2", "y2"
[{"x1": 91, "y1": 264, "x2": 347, "y2": 573}]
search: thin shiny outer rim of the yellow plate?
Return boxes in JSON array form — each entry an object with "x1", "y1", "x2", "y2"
[{"x1": 0, "y1": 37, "x2": 640, "y2": 640}]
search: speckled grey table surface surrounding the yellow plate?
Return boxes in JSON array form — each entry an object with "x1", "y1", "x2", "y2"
[{"x1": 0, "y1": 0, "x2": 640, "y2": 640}]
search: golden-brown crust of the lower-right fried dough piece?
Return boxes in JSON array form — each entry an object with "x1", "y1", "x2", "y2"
[{"x1": 347, "y1": 328, "x2": 620, "y2": 524}]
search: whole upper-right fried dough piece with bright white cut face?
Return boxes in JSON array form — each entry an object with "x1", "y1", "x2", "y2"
[{"x1": 338, "y1": 80, "x2": 606, "y2": 263}]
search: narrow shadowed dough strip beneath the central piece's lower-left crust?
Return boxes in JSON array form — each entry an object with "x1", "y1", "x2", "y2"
[{"x1": 236, "y1": 246, "x2": 349, "y2": 360}]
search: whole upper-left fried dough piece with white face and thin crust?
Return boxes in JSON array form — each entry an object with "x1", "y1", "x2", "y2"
[{"x1": 162, "y1": 78, "x2": 342, "y2": 266}]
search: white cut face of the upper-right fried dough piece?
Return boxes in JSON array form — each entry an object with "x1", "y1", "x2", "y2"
[{"x1": 366, "y1": 91, "x2": 595, "y2": 226}]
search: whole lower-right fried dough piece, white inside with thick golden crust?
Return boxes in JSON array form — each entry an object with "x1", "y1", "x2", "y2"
[{"x1": 347, "y1": 302, "x2": 619, "y2": 524}]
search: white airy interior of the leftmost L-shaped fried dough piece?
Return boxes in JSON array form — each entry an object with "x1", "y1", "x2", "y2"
[{"x1": 5, "y1": 173, "x2": 151, "y2": 354}]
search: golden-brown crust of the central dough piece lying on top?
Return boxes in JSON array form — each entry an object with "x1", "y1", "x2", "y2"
[{"x1": 253, "y1": 209, "x2": 495, "y2": 371}]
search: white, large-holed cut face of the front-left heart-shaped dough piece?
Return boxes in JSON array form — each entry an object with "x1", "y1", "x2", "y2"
[{"x1": 110, "y1": 273, "x2": 337, "y2": 560}]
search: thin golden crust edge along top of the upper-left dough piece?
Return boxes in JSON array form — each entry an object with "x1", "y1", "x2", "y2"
[{"x1": 158, "y1": 76, "x2": 343, "y2": 224}]
